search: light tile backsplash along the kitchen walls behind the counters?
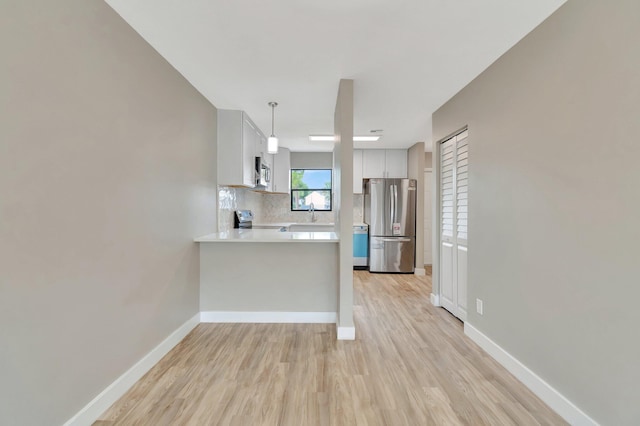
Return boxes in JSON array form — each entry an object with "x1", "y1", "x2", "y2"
[{"x1": 218, "y1": 186, "x2": 363, "y2": 232}]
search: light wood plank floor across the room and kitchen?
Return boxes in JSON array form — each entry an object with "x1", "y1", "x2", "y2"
[{"x1": 94, "y1": 271, "x2": 566, "y2": 426}]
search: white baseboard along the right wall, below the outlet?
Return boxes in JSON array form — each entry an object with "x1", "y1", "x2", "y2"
[{"x1": 462, "y1": 322, "x2": 598, "y2": 426}]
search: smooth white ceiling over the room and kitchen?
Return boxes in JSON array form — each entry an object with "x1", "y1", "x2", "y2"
[{"x1": 106, "y1": 0, "x2": 565, "y2": 151}]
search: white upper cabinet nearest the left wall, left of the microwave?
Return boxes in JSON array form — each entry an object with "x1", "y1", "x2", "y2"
[{"x1": 218, "y1": 109, "x2": 259, "y2": 188}]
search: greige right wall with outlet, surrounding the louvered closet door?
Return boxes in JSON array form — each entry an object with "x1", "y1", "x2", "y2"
[{"x1": 433, "y1": 0, "x2": 640, "y2": 425}]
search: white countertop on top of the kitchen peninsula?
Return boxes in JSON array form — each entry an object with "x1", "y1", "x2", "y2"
[{"x1": 194, "y1": 229, "x2": 340, "y2": 243}]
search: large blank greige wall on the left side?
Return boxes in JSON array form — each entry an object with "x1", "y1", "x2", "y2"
[{"x1": 0, "y1": 0, "x2": 216, "y2": 425}]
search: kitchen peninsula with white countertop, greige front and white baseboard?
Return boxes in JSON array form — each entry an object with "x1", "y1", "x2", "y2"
[{"x1": 195, "y1": 229, "x2": 339, "y2": 323}]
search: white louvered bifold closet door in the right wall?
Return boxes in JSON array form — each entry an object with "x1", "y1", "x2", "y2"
[{"x1": 440, "y1": 131, "x2": 469, "y2": 321}]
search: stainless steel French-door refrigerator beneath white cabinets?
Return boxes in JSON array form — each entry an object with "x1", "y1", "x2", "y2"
[{"x1": 364, "y1": 179, "x2": 416, "y2": 273}]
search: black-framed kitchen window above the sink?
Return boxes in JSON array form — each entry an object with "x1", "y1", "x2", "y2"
[{"x1": 291, "y1": 169, "x2": 332, "y2": 211}]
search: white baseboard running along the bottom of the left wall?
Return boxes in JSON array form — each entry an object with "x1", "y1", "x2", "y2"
[{"x1": 64, "y1": 314, "x2": 200, "y2": 426}]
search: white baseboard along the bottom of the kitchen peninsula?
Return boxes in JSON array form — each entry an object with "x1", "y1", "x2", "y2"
[{"x1": 200, "y1": 311, "x2": 337, "y2": 324}]
